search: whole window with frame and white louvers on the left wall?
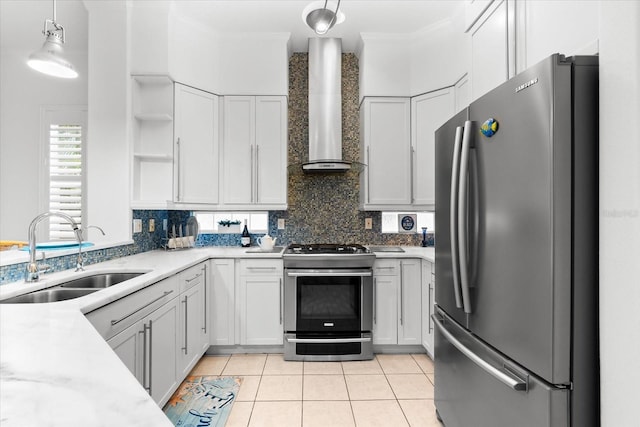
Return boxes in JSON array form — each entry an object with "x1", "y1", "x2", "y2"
[{"x1": 43, "y1": 108, "x2": 86, "y2": 240}]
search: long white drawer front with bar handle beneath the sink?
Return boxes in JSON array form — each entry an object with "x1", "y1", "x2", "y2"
[{"x1": 86, "y1": 277, "x2": 178, "y2": 339}]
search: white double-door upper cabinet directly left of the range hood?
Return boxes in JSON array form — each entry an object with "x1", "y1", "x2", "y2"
[{"x1": 220, "y1": 96, "x2": 287, "y2": 209}]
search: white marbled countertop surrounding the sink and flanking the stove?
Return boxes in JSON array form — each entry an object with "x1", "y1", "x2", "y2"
[{"x1": 0, "y1": 247, "x2": 435, "y2": 427}]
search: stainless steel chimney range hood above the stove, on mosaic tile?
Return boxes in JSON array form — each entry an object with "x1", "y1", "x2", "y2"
[{"x1": 302, "y1": 38, "x2": 351, "y2": 173}]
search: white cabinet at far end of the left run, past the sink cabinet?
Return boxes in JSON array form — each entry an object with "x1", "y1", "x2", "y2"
[{"x1": 177, "y1": 263, "x2": 209, "y2": 378}]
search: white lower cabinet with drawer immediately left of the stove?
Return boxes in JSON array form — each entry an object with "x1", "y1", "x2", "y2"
[{"x1": 236, "y1": 259, "x2": 284, "y2": 345}]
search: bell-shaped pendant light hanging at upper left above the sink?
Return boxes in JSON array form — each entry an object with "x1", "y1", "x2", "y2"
[{"x1": 27, "y1": 0, "x2": 78, "y2": 79}]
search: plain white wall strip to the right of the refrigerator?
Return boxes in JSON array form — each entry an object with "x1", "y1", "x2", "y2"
[{"x1": 587, "y1": 0, "x2": 640, "y2": 427}]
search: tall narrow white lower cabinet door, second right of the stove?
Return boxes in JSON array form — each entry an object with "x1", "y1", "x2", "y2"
[{"x1": 398, "y1": 259, "x2": 422, "y2": 345}]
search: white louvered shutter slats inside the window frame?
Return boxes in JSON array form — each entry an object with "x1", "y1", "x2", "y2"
[{"x1": 49, "y1": 124, "x2": 83, "y2": 240}]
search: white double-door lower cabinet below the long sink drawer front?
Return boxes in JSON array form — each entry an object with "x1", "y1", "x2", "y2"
[{"x1": 107, "y1": 298, "x2": 178, "y2": 406}]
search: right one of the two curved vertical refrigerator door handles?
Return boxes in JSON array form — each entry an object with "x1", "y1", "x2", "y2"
[{"x1": 457, "y1": 120, "x2": 472, "y2": 313}]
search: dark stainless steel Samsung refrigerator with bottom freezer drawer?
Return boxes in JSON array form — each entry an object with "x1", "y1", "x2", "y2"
[{"x1": 432, "y1": 54, "x2": 599, "y2": 427}]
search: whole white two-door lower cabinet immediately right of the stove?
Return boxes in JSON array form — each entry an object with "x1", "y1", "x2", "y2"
[{"x1": 373, "y1": 259, "x2": 422, "y2": 345}]
